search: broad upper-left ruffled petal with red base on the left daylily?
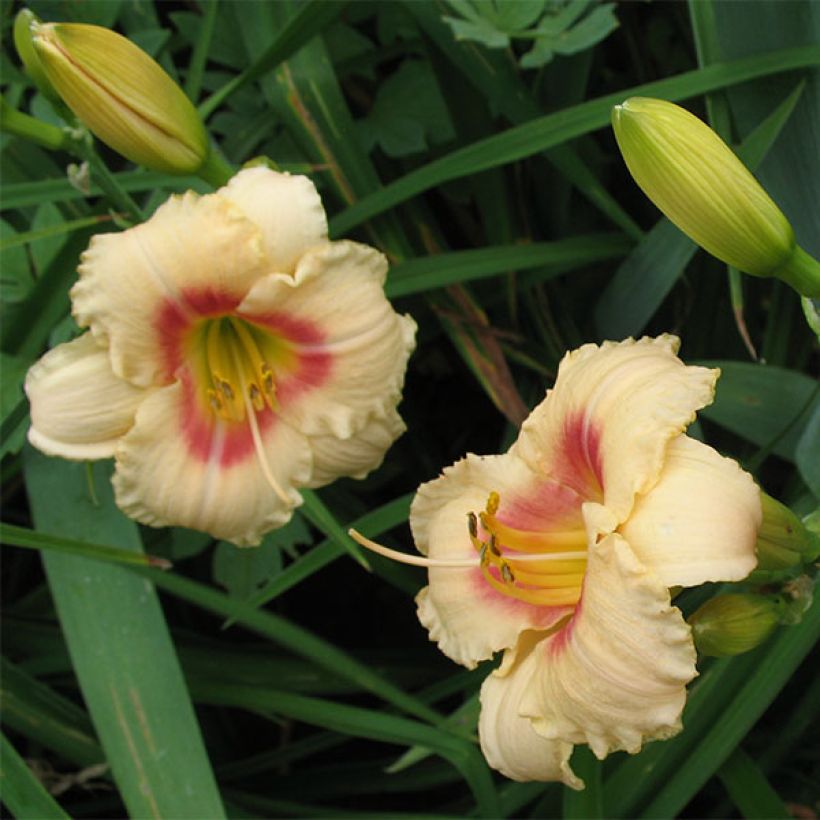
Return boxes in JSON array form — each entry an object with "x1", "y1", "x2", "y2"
[{"x1": 71, "y1": 191, "x2": 270, "y2": 387}]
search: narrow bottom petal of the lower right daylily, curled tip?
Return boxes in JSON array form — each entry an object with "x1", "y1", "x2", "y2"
[{"x1": 478, "y1": 636, "x2": 584, "y2": 789}]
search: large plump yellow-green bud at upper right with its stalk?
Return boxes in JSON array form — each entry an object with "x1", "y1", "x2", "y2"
[{"x1": 612, "y1": 97, "x2": 820, "y2": 297}]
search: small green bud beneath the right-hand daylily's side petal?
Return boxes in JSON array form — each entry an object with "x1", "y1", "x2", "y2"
[{"x1": 688, "y1": 593, "x2": 782, "y2": 657}]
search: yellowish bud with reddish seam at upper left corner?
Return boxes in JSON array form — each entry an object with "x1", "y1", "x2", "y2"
[{"x1": 30, "y1": 21, "x2": 209, "y2": 174}]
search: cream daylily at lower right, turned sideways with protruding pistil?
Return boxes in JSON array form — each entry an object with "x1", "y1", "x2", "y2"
[{"x1": 350, "y1": 336, "x2": 761, "y2": 788}]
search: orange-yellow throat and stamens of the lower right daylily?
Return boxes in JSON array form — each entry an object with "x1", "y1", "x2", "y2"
[{"x1": 467, "y1": 492, "x2": 587, "y2": 606}]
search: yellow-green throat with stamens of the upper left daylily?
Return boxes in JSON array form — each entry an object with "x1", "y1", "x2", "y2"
[{"x1": 203, "y1": 316, "x2": 277, "y2": 421}]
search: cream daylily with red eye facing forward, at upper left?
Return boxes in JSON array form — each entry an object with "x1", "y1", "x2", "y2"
[{"x1": 26, "y1": 167, "x2": 415, "y2": 545}]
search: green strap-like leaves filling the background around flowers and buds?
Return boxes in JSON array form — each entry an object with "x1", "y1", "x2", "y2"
[{"x1": 0, "y1": 0, "x2": 820, "y2": 820}]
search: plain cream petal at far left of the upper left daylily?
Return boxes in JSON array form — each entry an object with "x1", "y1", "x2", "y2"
[{"x1": 25, "y1": 333, "x2": 147, "y2": 459}]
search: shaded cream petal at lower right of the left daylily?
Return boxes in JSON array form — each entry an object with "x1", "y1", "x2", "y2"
[{"x1": 310, "y1": 410, "x2": 406, "y2": 487}]
